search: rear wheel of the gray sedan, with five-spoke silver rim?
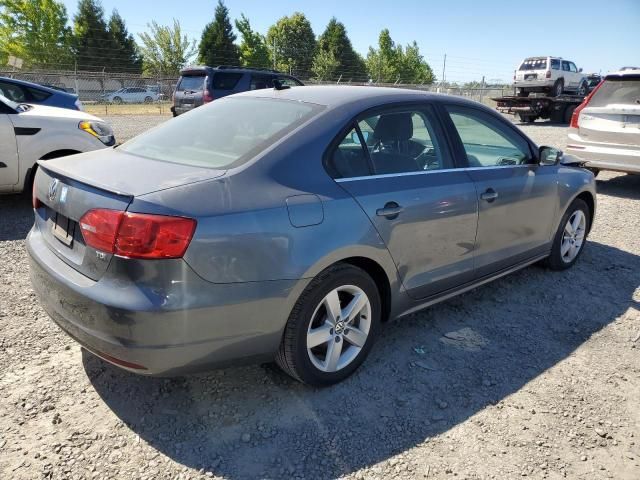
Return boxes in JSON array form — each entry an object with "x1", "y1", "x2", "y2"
[{"x1": 276, "y1": 264, "x2": 382, "y2": 386}]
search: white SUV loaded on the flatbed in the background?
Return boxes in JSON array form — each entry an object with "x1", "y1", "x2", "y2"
[{"x1": 513, "y1": 57, "x2": 588, "y2": 97}]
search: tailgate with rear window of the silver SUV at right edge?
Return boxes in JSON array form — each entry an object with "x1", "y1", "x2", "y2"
[{"x1": 579, "y1": 74, "x2": 640, "y2": 147}]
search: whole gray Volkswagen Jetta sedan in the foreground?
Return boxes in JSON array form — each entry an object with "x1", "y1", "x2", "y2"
[{"x1": 27, "y1": 86, "x2": 596, "y2": 385}]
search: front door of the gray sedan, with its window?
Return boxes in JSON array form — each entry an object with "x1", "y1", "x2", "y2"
[{"x1": 446, "y1": 105, "x2": 558, "y2": 278}]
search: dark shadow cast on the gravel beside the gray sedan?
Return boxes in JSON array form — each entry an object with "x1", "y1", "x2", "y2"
[{"x1": 83, "y1": 242, "x2": 640, "y2": 479}]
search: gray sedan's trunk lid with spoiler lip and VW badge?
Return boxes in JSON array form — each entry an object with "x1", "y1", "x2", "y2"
[{"x1": 33, "y1": 150, "x2": 224, "y2": 280}]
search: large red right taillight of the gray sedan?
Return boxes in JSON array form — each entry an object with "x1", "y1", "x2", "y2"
[{"x1": 80, "y1": 209, "x2": 196, "y2": 258}]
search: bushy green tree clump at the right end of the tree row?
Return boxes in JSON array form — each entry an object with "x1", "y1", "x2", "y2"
[{"x1": 366, "y1": 29, "x2": 435, "y2": 84}]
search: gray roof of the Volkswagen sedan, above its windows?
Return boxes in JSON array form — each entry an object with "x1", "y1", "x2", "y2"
[{"x1": 234, "y1": 85, "x2": 481, "y2": 109}]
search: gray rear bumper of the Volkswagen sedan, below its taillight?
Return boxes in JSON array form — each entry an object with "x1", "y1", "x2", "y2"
[{"x1": 27, "y1": 228, "x2": 306, "y2": 376}]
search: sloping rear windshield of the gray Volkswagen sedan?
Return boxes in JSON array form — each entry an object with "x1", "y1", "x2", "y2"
[{"x1": 119, "y1": 98, "x2": 323, "y2": 169}]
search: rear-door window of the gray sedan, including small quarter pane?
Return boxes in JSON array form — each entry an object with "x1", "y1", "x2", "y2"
[{"x1": 331, "y1": 109, "x2": 452, "y2": 178}]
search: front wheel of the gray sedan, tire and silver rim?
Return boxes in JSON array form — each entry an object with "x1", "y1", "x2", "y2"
[{"x1": 546, "y1": 198, "x2": 591, "y2": 270}]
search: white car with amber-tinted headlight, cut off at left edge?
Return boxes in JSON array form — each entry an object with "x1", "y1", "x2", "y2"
[{"x1": 0, "y1": 95, "x2": 115, "y2": 193}]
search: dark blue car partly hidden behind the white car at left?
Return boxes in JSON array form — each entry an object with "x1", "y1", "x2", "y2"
[{"x1": 0, "y1": 77, "x2": 83, "y2": 110}]
